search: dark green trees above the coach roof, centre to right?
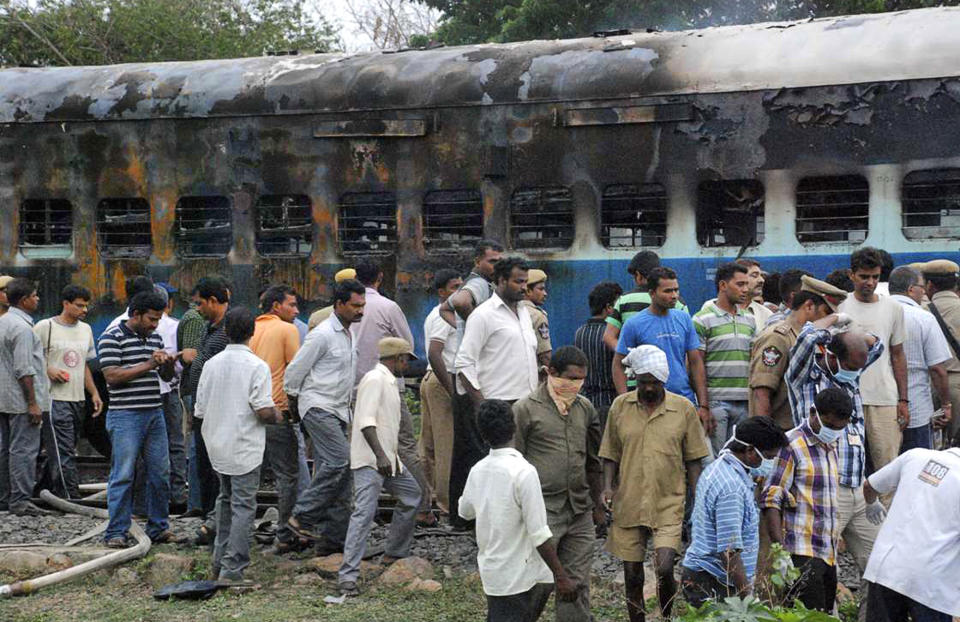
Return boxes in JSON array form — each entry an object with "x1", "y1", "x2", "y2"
[{"x1": 423, "y1": 0, "x2": 960, "y2": 45}]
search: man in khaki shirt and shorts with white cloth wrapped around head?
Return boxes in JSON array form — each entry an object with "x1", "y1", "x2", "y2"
[{"x1": 600, "y1": 345, "x2": 709, "y2": 622}]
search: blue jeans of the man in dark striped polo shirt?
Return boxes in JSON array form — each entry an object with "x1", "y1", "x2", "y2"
[{"x1": 104, "y1": 408, "x2": 170, "y2": 540}]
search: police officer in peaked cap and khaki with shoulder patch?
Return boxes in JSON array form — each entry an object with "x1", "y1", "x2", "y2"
[{"x1": 749, "y1": 275, "x2": 847, "y2": 431}]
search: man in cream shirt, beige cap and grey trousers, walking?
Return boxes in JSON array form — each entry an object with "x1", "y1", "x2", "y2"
[{"x1": 339, "y1": 337, "x2": 420, "y2": 596}]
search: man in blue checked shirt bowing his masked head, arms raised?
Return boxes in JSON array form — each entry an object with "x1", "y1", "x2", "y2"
[{"x1": 784, "y1": 313, "x2": 884, "y2": 592}]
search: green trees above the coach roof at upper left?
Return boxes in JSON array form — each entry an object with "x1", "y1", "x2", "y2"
[{"x1": 0, "y1": 0, "x2": 337, "y2": 65}]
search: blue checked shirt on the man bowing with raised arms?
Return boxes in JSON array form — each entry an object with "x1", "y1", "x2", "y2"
[{"x1": 784, "y1": 322, "x2": 883, "y2": 488}]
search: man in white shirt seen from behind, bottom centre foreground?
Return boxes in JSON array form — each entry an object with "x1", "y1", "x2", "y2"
[{"x1": 458, "y1": 400, "x2": 580, "y2": 622}]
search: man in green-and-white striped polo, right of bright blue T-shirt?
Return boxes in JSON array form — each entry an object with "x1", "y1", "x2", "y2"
[{"x1": 693, "y1": 263, "x2": 757, "y2": 453}]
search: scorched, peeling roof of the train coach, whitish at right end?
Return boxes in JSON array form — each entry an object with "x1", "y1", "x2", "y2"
[{"x1": 0, "y1": 8, "x2": 960, "y2": 123}]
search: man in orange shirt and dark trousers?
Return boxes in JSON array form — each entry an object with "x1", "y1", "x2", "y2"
[{"x1": 250, "y1": 285, "x2": 300, "y2": 553}]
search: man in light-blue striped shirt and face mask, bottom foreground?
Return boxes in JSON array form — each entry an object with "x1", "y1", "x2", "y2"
[{"x1": 681, "y1": 417, "x2": 787, "y2": 607}]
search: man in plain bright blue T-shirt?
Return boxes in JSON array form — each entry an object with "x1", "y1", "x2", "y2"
[{"x1": 613, "y1": 267, "x2": 713, "y2": 434}]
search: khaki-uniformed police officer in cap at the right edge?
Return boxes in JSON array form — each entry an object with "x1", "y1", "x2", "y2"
[{"x1": 917, "y1": 259, "x2": 960, "y2": 441}]
